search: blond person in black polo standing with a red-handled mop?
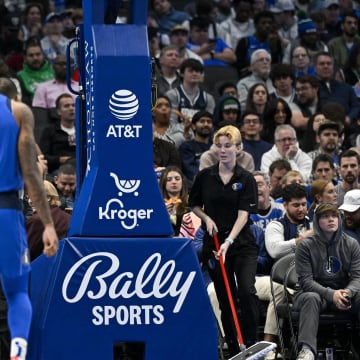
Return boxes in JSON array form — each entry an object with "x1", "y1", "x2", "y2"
[{"x1": 189, "y1": 126, "x2": 258, "y2": 355}]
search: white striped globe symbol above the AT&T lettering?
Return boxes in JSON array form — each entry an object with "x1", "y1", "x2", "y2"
[{"x1": 109, "y1": 89, "x2": 139, "y2": 120}]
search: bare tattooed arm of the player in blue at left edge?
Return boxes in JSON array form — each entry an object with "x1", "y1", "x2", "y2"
[{"x1": 12, "y1": 102, "x2": 58, "y2": 256}]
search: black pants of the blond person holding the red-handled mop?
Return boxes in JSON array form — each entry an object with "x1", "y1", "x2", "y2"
[{"x1": 208, "y1": 255, "x2": 259, "y2": 356}]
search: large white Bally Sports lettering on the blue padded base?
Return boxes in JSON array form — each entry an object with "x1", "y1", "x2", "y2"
[{"x1": 62, "y1": 252, "x2": 196, "y2": 326}]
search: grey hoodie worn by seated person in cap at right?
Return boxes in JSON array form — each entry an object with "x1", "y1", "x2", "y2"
[{"x1": 295, "y1": 214, "x2": 360, "y2": 302}]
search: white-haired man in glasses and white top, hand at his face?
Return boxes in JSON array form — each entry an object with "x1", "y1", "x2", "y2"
[{"x1": 261, "y1": 124, "x2": 312, "y2": 182}]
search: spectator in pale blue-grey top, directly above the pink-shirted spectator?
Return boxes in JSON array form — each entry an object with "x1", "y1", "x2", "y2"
[{"x1": 40, "y1": 13, "x2": 69, "y2": 63}]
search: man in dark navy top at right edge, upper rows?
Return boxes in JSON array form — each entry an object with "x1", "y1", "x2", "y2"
[{"x1": 314, "y1": 52, "x2": 360, "y2": 124}]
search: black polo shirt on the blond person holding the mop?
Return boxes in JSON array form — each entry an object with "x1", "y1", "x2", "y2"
[{"x1": 189, "y1": 164, "x2": 258, "y2": 257}]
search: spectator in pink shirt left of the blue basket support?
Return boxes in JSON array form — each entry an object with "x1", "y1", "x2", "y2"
[{"x1": 32, "y1": 55, "x2": 78, "y2": 109}]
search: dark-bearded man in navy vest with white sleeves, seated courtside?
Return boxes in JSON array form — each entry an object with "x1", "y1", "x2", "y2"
[{"x1": 265, "y1": 184, "x2": 312, "y2": 260}]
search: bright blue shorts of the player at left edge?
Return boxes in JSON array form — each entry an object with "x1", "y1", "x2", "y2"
[{"x1": 0, "y1": 208, "x2": 30, "y2": 278}]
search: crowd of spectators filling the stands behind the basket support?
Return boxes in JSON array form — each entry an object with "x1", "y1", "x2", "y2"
[{"x1": 0, "y1": 0, "x2": 360, "y2": 359}]
